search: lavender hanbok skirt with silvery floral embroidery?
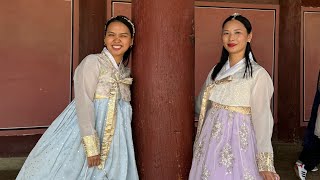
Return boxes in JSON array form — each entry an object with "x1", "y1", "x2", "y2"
[{"x1": 189, "y1": 103, "x2": 262, "y2": 180}]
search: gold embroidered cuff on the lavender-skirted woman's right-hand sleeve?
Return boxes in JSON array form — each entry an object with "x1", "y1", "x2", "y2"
[{"x1": 257, "y1": 152, "x2": 276, "y2": 173}]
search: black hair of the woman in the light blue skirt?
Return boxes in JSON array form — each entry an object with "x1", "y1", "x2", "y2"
[{"x1": 104, "y1": 15, "x2": 135, "y2": 66}]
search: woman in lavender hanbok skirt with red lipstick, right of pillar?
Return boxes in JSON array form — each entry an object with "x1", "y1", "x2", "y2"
[{"x1": 189, "y1": 13, "x2": 280, "y2": 180}]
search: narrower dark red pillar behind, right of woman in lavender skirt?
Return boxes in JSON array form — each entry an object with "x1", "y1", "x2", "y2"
[{"x1": 278, "y1": 0, "x2": 301, "y2": 141}]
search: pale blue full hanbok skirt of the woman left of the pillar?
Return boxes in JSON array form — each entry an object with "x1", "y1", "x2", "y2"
[{"x1": 17, "y1": 99, "x2": 139, "y2": 180}]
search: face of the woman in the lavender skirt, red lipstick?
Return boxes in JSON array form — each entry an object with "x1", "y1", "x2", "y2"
[{"x1": 222, "y1": 19, "x2": 252, "y2": 57}]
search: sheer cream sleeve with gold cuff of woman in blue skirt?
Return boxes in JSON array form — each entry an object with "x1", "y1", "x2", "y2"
[{"x1": 74, "y1": 55, "x2": 100, "y2": 157}]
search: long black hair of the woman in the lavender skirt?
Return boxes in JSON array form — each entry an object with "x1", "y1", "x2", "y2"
[{"x1": 211, "y1": 14, "x2": 257, "y2": 80}]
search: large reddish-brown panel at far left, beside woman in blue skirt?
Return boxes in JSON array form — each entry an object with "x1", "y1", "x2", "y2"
[{"x1": 0, "y1": 0, "x2": 72, "y2": 134}]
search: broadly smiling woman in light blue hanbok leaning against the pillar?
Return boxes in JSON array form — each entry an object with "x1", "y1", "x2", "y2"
[{"x1": 17, "y1": 16, "x2": 139, "y2": 180}]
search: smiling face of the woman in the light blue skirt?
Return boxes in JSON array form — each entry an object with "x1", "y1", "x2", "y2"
[{"x1": 104, "y1": 21, "x2": 133, "y2": 63}]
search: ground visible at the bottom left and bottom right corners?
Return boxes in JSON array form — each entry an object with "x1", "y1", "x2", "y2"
[{"x1": 0, "y1": 142, "x2": 320, "y2": 180}]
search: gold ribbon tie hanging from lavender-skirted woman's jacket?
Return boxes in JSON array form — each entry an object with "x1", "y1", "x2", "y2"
[{"x1": 195, "y1": 76, "x2": 232, "y2": 148}]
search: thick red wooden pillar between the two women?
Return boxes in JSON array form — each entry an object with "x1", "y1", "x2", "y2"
[{"x1": 132, "y1": 0, "x2": 194, "y2": 180}]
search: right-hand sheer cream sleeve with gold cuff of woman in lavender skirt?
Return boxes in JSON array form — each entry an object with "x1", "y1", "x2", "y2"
[{"x1": 250, "y1": 69, "x2": 275, "y2": 172}]
